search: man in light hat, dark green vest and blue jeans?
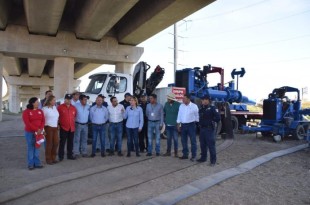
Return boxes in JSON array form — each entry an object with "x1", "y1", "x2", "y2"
[{"x1": 164, "y1": 93, "x2": 180, "y2": 157}]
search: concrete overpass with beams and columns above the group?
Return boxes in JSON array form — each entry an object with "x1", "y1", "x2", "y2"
[{"x1": 0, "y1": 0, "x2": 214, "y2": 120}]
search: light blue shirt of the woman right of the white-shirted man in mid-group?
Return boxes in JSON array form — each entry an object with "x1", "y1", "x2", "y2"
[{"x1": 123, "y1": 106, "x2": 144, "y2": 129}]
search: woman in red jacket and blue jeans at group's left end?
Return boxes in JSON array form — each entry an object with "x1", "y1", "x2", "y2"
[{"x1": 23, "y1": 97, "x2": 45, "y2": 170}]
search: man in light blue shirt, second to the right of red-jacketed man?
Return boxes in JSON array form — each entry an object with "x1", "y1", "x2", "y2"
[{"x1": 89, "y1": 95, "x2": 109, "y2": 157}]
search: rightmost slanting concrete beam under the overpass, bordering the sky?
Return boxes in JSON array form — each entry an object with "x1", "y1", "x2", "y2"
[{"x1": 115, "y1": 0, "x2": 215, "y2": 45}]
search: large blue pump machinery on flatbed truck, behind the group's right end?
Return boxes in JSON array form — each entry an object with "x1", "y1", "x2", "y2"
[{"x1": 173, "y1": 65, "x2": 262, "y2": 136}]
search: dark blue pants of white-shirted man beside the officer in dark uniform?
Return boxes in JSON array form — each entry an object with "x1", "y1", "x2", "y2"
[{"x1": 181, "y1": 122, "x2": 197, "y2": 158}]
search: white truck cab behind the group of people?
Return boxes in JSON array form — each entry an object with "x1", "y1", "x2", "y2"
[{"x1": 84, "y1": 72, "x2": 133, "y2": 104}]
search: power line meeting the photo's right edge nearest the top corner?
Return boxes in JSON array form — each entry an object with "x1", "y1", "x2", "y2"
[{"x1": 189, "y1": 10, "x2": 310, "y2": 38}]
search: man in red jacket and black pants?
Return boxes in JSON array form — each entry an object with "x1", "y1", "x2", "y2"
[{"x1": 57, "y1": 94, "x2": 76, "y2": 161}]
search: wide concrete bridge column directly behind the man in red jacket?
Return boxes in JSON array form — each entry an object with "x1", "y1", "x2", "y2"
[{"x1": 54, "y1": 57, "x2": 74, "y2": 99}]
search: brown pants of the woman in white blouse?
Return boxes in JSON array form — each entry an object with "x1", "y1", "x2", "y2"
[{"x1": 44, "y1": 126, "x2": 59, "y2": 163}]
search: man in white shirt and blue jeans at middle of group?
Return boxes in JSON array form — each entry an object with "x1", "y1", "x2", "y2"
[{"x1": 108, "y1": 97, "x2": 125, "y2": 156}]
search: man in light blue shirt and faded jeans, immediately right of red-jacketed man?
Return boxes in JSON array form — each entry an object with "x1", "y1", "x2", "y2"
[{"x1": 73, "y1": 94, "x2": 90, "y2": 157}]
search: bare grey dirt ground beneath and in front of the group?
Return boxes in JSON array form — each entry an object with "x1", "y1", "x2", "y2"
[{"x1": 0, "y1": 113, "x2": 310, "y2": 205}]
